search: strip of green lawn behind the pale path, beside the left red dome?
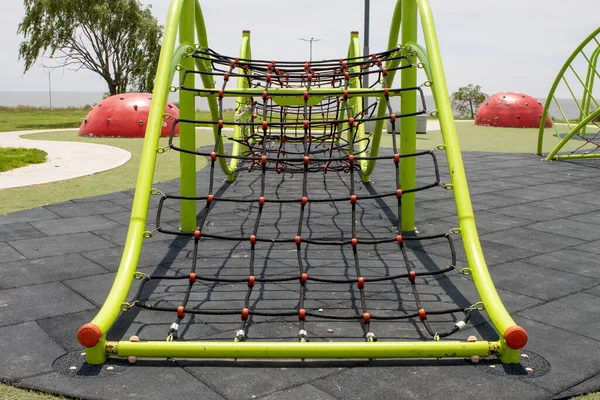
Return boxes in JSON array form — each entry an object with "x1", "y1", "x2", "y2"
[{"x1": 0, "y1": 106, "x2": 235, "y2": 132}]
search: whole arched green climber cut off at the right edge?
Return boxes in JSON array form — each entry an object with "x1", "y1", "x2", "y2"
[{"x1": 537, "y1": 27, "x2": 600, "y2": 161}]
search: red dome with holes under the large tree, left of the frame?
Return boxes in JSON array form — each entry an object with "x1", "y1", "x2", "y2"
[{"x1": 78, "y1": 93, "x2": 179, "y2": 138}]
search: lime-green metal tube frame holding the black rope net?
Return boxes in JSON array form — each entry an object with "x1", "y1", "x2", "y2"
[{"x1": 81, "y1": 0, "x2": 524, "y2": 364}]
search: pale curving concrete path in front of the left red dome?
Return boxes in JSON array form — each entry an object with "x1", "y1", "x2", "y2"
[{"x1": 0, "y1": 129, "x2": 131, "y2": 189}]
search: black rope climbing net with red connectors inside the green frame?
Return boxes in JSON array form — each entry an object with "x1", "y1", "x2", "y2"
[{"x1": 123, "y1": 49, "x2": 477, "y2": 341}]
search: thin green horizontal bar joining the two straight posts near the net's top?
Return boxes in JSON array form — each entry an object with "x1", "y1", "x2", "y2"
[{"x1": 186, "y1": 88, "x2": 404, "y2": 97}]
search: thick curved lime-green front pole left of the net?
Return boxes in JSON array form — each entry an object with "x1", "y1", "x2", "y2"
[{"x1": 86, "y1": 0, "x2": 184, "y2": 364}]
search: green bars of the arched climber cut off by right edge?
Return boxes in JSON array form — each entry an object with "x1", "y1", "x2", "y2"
[{"x1": 536, "y1": 26, "x2": 600, "y2": 161}]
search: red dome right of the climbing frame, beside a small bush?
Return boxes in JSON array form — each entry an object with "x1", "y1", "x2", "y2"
[{"x1": 475, "y1": 92, "x2": 552, "y2": 128}]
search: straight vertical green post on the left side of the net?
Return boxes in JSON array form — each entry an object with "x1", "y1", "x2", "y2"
[{"x1": 179, "y1": 0, "x2": 196, "y2": 231}]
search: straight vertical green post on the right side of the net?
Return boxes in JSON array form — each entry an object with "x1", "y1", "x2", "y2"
[{"x1": 400, "y1": 0, "x2": 417, "y2": 232}]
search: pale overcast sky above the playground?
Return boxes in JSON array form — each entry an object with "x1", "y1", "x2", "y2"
[{"x1": 0, "y1": 0, "x2": 600, "y2": 97}]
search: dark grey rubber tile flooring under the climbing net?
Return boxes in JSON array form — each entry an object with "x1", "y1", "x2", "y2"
[{"x1": 0, "y1": 152, "x2": 600, "y2": 399}]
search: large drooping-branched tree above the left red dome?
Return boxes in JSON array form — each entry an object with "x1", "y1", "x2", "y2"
[{"x1": 17, "y1": 0, "x2": 163, "y2": 95}]
